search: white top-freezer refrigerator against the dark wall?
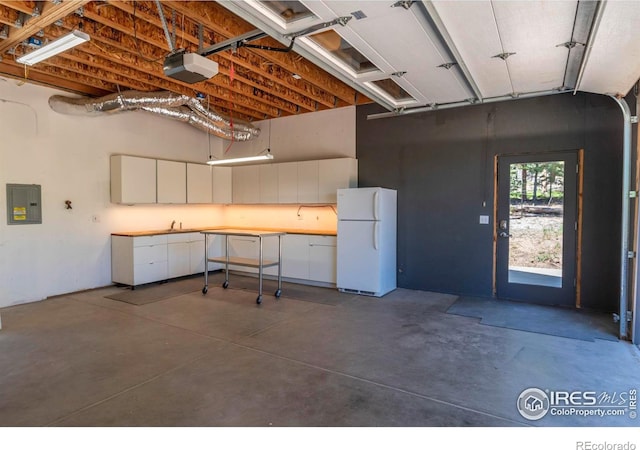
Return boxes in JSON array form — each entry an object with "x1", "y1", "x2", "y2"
[{"x1": 336, "y1": 187, "x2": 398, "y2": 297}]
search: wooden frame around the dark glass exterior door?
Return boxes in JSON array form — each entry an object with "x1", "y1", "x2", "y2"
[{"x1": 492, "y1": 149, "x2": 584, "y2": 308}]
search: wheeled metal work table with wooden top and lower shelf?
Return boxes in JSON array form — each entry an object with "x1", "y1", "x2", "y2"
[{"x1": 201, "y1": 228, "x2": 287, "y2": 305}]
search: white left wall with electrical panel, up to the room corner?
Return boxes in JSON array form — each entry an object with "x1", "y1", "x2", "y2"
[{"x1": 0, "y1": 78, "x2": 228, "y2": 307}]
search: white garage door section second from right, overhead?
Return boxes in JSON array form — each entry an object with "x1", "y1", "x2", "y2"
[{"x1": 493, "y1": 1, "x2": 578, "y2": 93}]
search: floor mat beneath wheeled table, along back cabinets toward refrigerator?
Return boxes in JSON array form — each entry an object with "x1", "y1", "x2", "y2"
[{"x1": 200, "y1": 273, "x2": 353, "y2": 306}]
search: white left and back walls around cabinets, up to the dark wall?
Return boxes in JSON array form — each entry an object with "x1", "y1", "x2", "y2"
[{"x1": 0, "y1": 77, "x2": 355, "y2": 307}]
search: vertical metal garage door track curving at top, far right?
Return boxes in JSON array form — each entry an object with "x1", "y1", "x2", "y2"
[{"x1": 610, "y1": 95, "x2": 631, "y2": 339}]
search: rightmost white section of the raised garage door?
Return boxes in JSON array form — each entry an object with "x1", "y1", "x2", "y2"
[{"x1": 578, "y1": 1, "x2": 640, "y2": 95}]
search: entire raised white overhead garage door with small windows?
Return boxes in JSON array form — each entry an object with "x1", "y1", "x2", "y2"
[{"x1": 226, "y1": 0, "x2": 640, "y2": 110}]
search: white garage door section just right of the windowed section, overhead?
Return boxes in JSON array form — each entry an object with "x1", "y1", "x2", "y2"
[{"x1": 433, "y1": 1, "x2": 513, "y2": 97}]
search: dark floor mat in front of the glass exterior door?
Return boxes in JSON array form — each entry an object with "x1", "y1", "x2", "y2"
[{"x1": 447, "y1": 297, "x2": 618, "y2": 342}]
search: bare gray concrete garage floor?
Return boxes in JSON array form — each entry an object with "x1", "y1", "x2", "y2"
[{"x1": 0, "y1": 274, "x2": 640, "y2": 427}]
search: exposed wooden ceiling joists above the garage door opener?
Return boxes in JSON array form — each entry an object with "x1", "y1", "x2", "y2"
[{"x1": 0, "y1": 0, "x2": 369, "y2": 126}]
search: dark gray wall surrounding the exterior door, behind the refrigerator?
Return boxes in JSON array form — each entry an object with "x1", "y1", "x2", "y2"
[{"x1": 356, "y1": 94, "x2": 622, "y2": 311}]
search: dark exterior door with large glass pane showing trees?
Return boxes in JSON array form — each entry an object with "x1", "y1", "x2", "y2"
[{"x1": 496, "y1": 152, "x2": 577, "y2": 306}]
